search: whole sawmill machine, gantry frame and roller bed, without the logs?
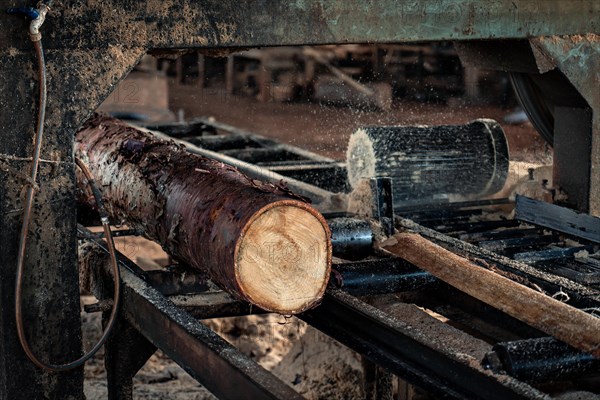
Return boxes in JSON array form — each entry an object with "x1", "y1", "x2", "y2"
[{"x1": 0, "y1": 0, "x2": 600, "y2": 399}]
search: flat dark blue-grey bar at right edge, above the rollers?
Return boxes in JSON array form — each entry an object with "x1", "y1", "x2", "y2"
[{"x1": 515, "y1": 195, "x2": 600, "y2": 243}]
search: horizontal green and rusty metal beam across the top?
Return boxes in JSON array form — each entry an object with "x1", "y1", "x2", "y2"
[{"x1": 0, "y1": 0, "x2": 600, "y2": 48}]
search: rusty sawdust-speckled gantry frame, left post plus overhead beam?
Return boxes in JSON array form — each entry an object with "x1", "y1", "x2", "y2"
[{"x1": 0, "y1": 0, "x2": 600, "y2": 399}]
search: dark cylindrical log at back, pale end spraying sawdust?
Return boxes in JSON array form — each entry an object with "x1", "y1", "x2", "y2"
[{"x1": 346, "y1": 119, "x2": 508, "y2": 204}]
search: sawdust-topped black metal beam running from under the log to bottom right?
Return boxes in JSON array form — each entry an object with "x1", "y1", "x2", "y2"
[{"x1": 300, "y1": 289, "x2": 548, "y2": 400}]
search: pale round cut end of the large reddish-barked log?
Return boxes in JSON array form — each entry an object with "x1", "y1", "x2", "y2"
[{"x1": 235, "y1": 200, "x2": 331, "y2": 315}]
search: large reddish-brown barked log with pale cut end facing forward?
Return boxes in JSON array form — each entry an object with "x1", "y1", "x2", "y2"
[{"x1": 75, "y1": 115, "x2": 331, "y2": 315}]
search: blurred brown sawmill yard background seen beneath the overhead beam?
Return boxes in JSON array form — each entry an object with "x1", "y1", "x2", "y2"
[{"x1": 100, "y1": 42, "x2": 551, "y2": 164}]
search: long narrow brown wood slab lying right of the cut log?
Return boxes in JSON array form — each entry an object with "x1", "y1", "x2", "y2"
[{"x1": 380, "y1": 232, "x2": 600, "y2": 358}]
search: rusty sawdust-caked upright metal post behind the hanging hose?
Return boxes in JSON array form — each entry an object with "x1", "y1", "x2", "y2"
[{"x1": 0, "y1": 27, "x2": 145, "y2": 394}]
